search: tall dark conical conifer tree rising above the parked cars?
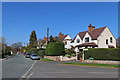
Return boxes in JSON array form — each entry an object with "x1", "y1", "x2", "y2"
[{"x1": 29, "y1": 30, "x2": 37, "y2": 48}]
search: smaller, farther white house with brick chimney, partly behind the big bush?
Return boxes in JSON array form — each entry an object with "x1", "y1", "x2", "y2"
[{"x1": 59, "y1": 32, "x2": 72, "y2": 49}]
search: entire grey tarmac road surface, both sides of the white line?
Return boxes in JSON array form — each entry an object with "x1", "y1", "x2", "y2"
[{"x1": 2, "y1": 54, "x2": 118, "y2": 80}]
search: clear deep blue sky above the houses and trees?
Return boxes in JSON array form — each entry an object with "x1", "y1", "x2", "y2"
[{"x1": 2, "y1": 2, "x2": 118, "y2": 45}]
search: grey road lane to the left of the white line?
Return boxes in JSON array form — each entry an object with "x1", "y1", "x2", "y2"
[{"x1": 2, "y1": 54, "x2": 34, "y2": 78}]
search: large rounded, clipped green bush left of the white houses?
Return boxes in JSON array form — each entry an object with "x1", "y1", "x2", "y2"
[{"x1": 45, "y1": 42, "x2": 64, "y2": 56}]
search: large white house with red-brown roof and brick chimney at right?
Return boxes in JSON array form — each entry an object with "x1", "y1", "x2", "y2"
[{"x1": 70, "y1": 24, "x2": 116, "y2": 51}]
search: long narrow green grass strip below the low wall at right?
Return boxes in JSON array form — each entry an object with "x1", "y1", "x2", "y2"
[{"x1": 63, "y1": 63, "x2": 120, "y2": 68}]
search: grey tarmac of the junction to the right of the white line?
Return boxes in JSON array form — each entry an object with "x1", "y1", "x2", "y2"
[{"x1": 26, "y1": 61, "x2": 118, "y2": 78}]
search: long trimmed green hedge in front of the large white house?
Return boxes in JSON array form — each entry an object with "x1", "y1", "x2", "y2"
[{"x1": 85, "y1": 48, "x2": 120, "y2": 61}]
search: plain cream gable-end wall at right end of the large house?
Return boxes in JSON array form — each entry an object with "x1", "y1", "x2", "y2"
[{"x1": 98, "y1": 27, "x2": 116, "y2": 48}]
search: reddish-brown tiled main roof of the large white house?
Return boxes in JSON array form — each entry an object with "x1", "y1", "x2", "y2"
[{"x1": 72, "y1": 27, "x2": 106, "y2": 42}]
